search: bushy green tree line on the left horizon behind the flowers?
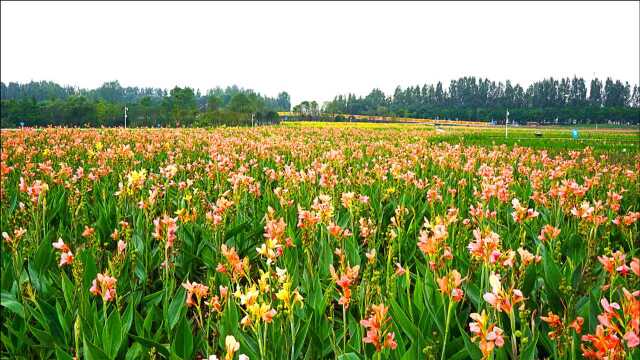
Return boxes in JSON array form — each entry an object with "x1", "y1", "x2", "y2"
[{"x1": 0, "y1": 81, "x2": 291, "y2": 127}]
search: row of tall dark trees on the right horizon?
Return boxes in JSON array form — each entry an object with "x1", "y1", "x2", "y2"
[{"x1": 320, "y1": 76, "x2": 640, "y2": 124}]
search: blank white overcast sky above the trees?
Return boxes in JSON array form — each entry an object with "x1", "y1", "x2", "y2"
[{"x1": 1, "y1": 1, "x2": 640, "y2": 104}]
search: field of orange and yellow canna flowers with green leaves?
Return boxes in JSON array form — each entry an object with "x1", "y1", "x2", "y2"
[{"x1": 0, "y1": 126, "x2": 640, "y2": 360}]
